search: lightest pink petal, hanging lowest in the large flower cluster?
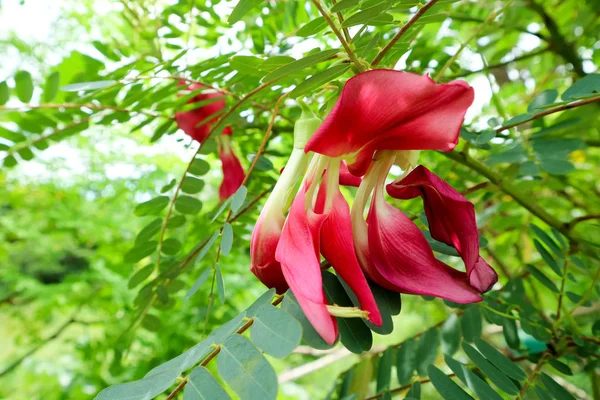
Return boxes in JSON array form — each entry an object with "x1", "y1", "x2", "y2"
[{"x1": 275, "y1": 185, "x2": 338, "y2": 344}]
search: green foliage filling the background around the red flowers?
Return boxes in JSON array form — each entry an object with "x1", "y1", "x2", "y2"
[{"x1": 0, "y1": 0, "x2": 600, "y2": 400}]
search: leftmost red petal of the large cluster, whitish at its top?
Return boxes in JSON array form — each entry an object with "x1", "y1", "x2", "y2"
[{"x1": 250, "y1": 209, "x2": 288, "y2": 294}]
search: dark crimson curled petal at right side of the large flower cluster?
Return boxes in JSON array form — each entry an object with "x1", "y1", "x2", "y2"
[{"x1": 387, "y1": 165, "x2": 498, "y2": 293}]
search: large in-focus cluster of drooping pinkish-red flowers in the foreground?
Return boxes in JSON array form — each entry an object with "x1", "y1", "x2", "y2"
[{"x1": 251, "y1": 70, "x2": 497, "y2": 344}]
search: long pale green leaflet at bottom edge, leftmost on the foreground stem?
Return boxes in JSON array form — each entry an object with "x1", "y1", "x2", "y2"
[{"x1": 94, "y1": 370, "x2": 179, "y2": 400}]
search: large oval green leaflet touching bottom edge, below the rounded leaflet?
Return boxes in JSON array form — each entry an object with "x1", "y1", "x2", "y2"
[{"x1": 217, "y1": 334, "x2": 277, "y2": 400}]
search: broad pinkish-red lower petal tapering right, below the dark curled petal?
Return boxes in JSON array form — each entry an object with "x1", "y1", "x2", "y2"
[{"x1": 367, "y1": 188, "x2": 481, "y2": 304}]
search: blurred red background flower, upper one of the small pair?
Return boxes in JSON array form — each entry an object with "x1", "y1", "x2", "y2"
[{"x1": 175, "y1": 83, "x2": 225, "y2": 143}]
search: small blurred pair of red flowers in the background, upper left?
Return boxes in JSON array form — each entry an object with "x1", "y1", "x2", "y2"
[{"x1": 175, "y1": 83, "x2": 245, "y2": 201}]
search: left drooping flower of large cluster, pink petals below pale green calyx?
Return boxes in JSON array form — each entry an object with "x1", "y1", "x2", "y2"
[{"x1": 251, "y1": 103, "x2": 382, "y2": 344}]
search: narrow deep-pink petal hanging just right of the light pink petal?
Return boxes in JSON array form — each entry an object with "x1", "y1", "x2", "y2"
[{"x1": 319, "y1": 184, "x2": 383, "y2": 326}]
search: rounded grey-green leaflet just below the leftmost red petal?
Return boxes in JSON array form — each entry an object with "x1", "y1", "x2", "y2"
[{"x1": 250, "y1": 304, "x2": 302, "y2": 358}]
